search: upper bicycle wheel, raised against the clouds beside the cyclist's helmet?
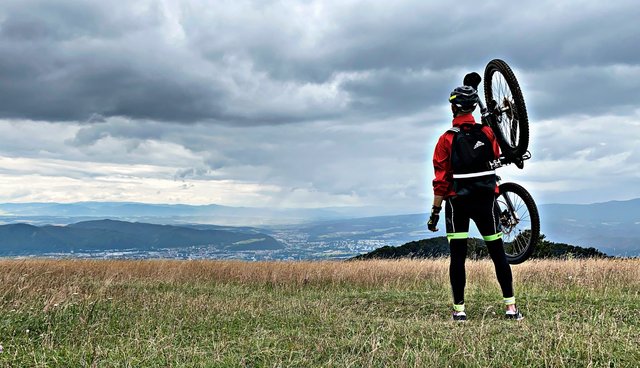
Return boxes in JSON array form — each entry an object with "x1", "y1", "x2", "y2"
[{"x1": 484, "y1": 59, "x2": 529, "y2": 157}]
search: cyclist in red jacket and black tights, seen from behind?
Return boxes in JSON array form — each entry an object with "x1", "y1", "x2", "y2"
[{"x1": 428, "y1": 79, "x2": 524, "y2": 321}]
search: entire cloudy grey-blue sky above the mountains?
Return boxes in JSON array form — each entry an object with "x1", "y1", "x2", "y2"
[{"x1": 0, "y1": 0, "x2": 640, "y2": 214}]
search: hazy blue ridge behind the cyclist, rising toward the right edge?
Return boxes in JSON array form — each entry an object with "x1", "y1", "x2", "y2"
[{"x1": 278, "y1": 199, "x2": 640, "y2": 257}]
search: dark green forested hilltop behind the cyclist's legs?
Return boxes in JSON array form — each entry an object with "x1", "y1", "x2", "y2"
[{"x1": 351, "y1": 235, "x2": 609, "y2": 260}]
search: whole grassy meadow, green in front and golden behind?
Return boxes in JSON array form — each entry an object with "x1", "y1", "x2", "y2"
[{"x1": 0, "y1": 259, "x2": 640, "y2": 367}]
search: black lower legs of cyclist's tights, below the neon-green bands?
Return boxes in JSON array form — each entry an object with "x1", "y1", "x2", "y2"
[{"x1": 449, "y1": 239, "x2": 513, "y2": 304}]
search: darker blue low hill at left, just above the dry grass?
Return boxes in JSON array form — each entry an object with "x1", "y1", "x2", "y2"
[{"x1": 0, "y1": 220, "x2": 284, "y2": 256}]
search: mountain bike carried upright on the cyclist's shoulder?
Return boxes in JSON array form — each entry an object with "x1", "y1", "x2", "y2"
[{"x1": 464, "y1": 59, "x2": 540, "y2": 264}]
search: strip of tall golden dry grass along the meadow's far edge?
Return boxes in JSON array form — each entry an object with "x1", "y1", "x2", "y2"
[{"x1": 0, "y1": 259, "x2": 640, "y2": 291}]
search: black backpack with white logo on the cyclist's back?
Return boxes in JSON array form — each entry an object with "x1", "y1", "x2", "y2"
[{"x1": 449, "y1": 124, "x2": 497, "y2": 196}]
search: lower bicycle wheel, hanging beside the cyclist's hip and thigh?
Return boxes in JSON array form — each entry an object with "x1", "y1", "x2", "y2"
[{"x1": 496, "y1": 183, "x2": 540, "y2": 264}]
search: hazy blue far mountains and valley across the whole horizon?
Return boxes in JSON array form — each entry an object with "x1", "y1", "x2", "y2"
[{"x1": 0, "y1": 198, "x2": 640, "y2": 256}]
